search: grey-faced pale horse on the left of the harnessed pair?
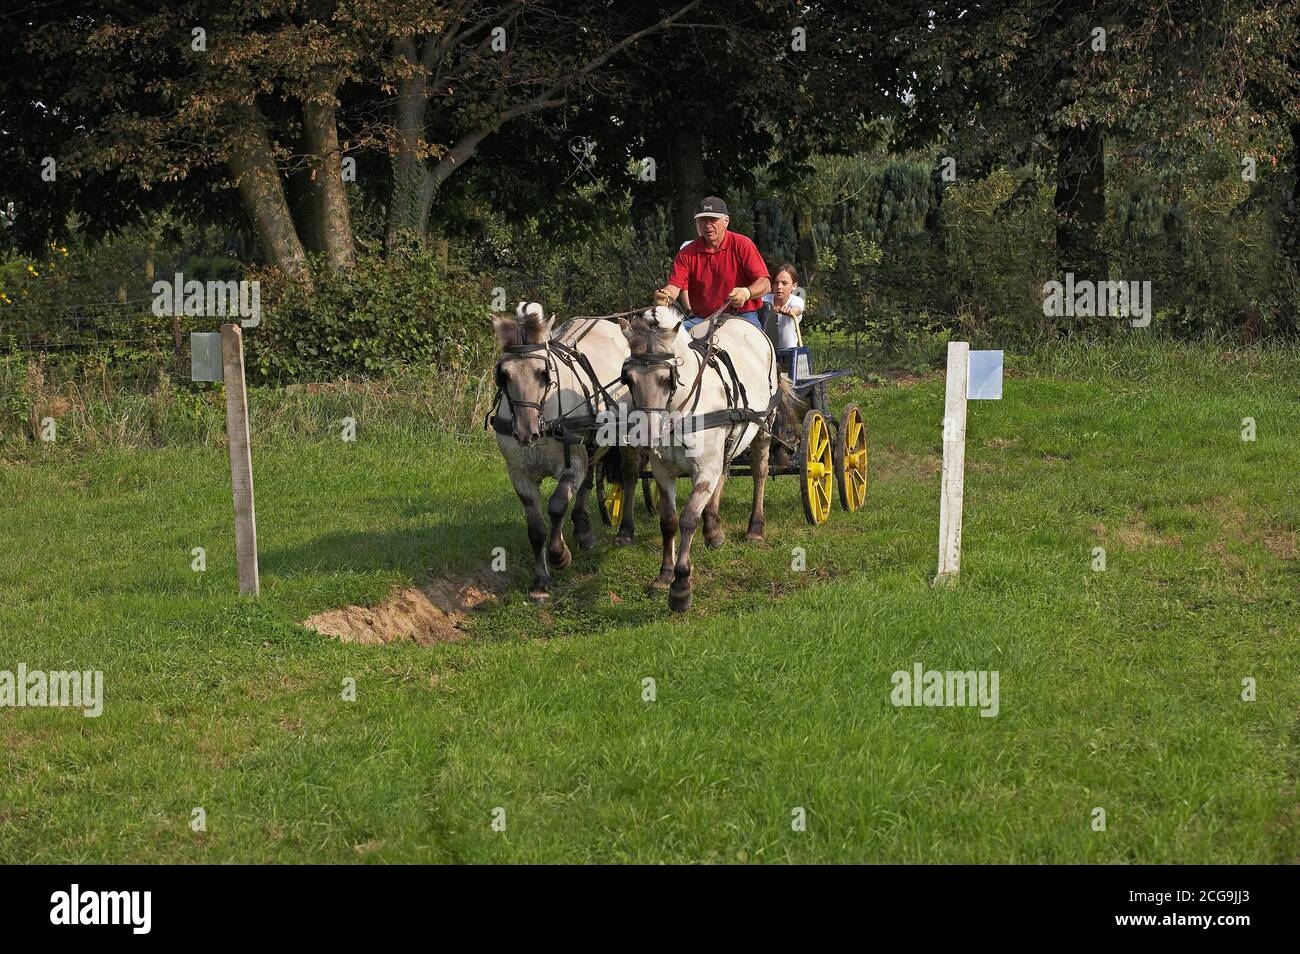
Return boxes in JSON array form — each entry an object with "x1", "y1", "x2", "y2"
[{"x1": 489, "y1": 302, "x2": 638, "y2": 603}]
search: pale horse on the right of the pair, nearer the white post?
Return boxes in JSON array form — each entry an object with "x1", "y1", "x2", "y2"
[{"x1": 621, "y1": 305, "x2": 780, "y2": 612}]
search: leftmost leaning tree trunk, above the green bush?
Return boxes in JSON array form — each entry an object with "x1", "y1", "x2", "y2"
[{"x1": 226, "y1": 105, "x2": 311, "y2": 285}]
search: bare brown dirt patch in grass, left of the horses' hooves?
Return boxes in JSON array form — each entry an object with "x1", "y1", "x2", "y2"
[{"x1": 303, "y1": 572, "x2": 502, "y2": 646}]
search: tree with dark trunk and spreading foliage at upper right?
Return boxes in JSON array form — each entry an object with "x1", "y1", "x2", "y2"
[{"x1": 902, "y1": 0, "x2": 1296, "y2": 306}]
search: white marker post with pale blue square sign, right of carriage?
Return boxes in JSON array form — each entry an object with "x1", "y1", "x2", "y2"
[{"x1": 935, "y1": 342, "x2": 1002, "y2": 584}]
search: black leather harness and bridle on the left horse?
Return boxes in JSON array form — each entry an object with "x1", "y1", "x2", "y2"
[{"x1": 484, "y1": 318, "x2": 618, "y2": 467}]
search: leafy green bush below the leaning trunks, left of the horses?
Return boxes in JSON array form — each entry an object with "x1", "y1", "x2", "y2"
[{"x1": 246, "y1": 251, "x2": 490, "y2": 383}]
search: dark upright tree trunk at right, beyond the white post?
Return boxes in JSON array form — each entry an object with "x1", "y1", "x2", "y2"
[{"x1": 1054, "y1": 125, "x2": 1108, "y2": 295}]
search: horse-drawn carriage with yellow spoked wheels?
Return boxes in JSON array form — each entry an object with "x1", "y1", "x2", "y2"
[{"x1": 595, "y1": 305, "x2": 867, "y2": 526}]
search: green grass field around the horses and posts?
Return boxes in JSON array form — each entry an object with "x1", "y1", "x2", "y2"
[{"x1": 0, "y1": 346, "x2": 1300, "y2": 863}]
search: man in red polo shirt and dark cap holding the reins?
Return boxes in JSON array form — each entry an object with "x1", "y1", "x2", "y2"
[{"x1": 654, "y1": 195, "x2": 772, "y2": 331}]
